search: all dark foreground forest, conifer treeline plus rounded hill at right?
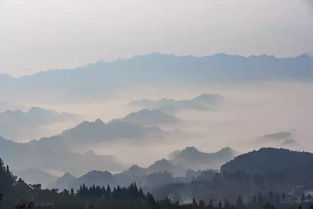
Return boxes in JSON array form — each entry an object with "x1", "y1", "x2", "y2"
[{"x1": 0, "y1": 148, "x2": 313, "y2": 209}]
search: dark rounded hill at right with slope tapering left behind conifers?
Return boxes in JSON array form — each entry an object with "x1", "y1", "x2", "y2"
[{"x1": 154, "y1": 148, "x2": 313, "y2": 202}]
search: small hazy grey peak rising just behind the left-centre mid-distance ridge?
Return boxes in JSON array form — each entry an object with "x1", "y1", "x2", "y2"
[{"x1": 114, "y1": 109, "x2": 182, "y2": 126}]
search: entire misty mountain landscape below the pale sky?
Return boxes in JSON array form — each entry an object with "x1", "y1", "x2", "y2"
[{"x1": 0, "y1": 53, "x2": 313, "y2": 209}]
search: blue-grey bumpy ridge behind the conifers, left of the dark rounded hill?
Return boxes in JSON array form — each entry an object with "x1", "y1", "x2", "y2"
[{"x1": 50, "y1": 147, "x2": 234, "y2": 191}]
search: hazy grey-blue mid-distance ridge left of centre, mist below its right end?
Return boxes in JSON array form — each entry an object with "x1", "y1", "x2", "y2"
[{"x1": 31, "y1": 119, "x2": 168, "y2": 150}]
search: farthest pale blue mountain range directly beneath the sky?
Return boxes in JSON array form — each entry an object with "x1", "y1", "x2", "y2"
[{"x1": 0, "y1": 53, "x2": 313, "y2": 102}]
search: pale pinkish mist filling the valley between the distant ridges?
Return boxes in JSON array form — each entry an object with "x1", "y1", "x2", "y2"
[{"x1": 18, "y1": 82, "x2": 313, "y2": 166}]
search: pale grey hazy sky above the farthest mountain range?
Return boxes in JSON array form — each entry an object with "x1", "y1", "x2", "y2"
[{"x1": 0, "y1": 0, "x2": 313, "y2": 75}]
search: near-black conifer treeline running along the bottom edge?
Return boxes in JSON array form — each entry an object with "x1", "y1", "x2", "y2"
[{"x1": 0, "y1": 155, "x2": 313, "y2": 209}]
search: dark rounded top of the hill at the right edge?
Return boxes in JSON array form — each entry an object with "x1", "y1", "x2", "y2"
[{"x1": 221, "y1": 148, "x2": 313, "y2": 180}]
